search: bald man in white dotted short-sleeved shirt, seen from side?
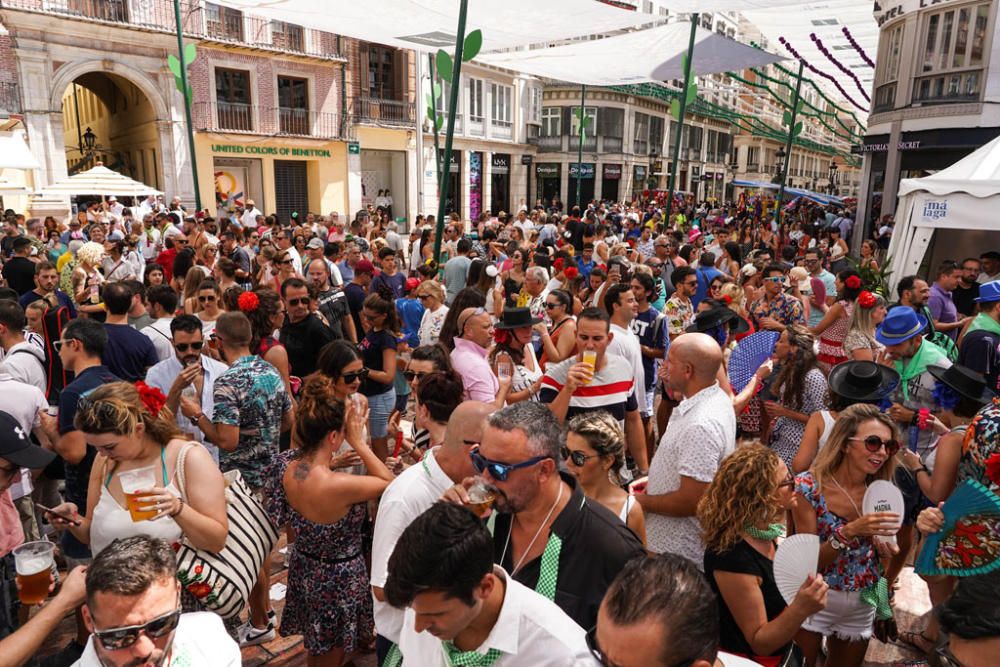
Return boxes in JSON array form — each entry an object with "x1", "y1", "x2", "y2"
[{"x1": 636, "y1": 333, "x2": 736, "y2": 569}]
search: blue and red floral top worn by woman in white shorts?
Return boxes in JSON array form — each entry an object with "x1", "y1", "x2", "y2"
[{"x1": 795, "y1": 472, "x2": 879, "y2": 591}]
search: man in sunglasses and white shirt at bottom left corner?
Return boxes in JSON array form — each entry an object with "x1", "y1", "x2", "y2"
[{"x1": 73, "y1": 535, "x2": 242, "y2": 667}]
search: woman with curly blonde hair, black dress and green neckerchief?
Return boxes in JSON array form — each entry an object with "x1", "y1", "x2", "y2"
[{"x1": 698, "y1": 443, "x2": 829, "y2": 665}]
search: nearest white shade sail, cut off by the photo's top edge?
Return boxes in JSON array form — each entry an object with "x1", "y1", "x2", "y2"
[{"x1": 218, "y1": 0, "x2": 658, "y2": 52}]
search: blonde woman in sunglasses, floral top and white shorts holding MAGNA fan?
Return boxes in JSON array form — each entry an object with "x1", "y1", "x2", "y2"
[{"x1": 792, "y1": 404, "x2": 902, "y2": 667}]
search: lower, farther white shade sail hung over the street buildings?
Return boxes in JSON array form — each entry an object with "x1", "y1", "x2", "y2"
[{"x1": 477, "y1": 22, "x2": 783, "y2": 86}]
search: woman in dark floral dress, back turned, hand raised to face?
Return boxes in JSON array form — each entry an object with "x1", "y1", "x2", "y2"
[{"x1": 265, "y1": 374, "x2": 393, "y2": 667}]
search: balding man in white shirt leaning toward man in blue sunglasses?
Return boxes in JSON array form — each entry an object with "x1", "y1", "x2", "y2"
[{"x1": 371, "y1": 401, "x2": 496, "y2": 664}]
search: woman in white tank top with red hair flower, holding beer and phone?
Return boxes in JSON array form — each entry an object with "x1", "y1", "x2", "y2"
[{"x1": 46, "y1": 382, "x2": 229, "y2": 556}]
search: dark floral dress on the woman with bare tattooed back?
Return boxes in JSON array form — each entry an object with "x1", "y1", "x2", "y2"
[{"x1": 265, "y1": 450, "x2": 375, "y2": 655}]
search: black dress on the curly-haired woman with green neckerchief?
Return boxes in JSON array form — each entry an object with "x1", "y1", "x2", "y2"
[{"x1": 704, "y1": 540, "x2": 788, "y2": 656}]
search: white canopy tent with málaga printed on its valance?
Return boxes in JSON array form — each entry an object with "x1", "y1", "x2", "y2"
[{"x1": 889, "y1": 137, "x2": 1000, "y2": 287}]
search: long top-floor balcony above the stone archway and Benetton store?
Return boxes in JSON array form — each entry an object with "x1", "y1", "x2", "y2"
[{"x1": 0, "y1": 0, "x2": 344, "y2": 60}]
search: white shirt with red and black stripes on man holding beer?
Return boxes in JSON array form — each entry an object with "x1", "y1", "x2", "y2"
[{"x1": 539, "y1": 353, "x2": 639, "y2": 424}]
